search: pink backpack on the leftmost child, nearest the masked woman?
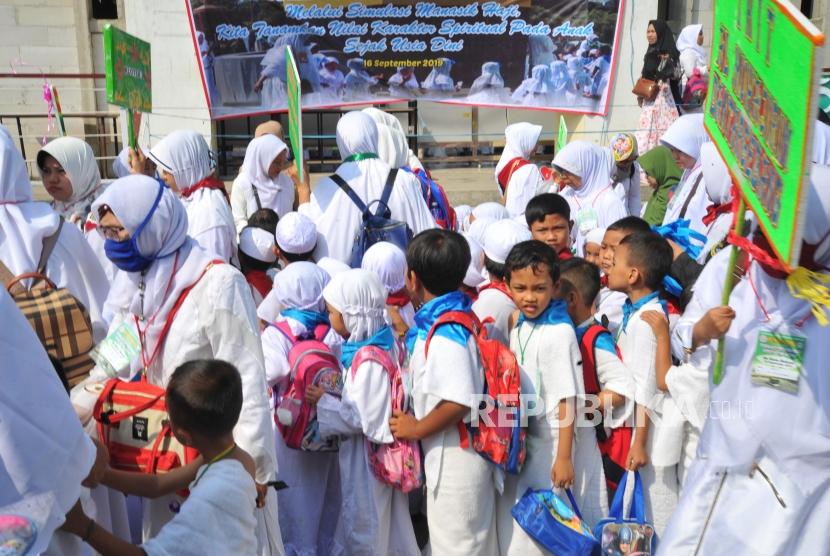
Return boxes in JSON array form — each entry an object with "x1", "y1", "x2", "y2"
[{"x1": 273, "y1": 321, "x2": 343, "y2": 452}]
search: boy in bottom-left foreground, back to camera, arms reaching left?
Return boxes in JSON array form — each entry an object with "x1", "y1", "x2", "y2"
[{"x1": 63, "y1": 360, "x2": 257, "y2": 556}]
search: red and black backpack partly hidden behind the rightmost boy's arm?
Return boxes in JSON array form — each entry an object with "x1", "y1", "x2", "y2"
[{"x1": 579, "y1": 323, "x2": 633, "y2": 490}]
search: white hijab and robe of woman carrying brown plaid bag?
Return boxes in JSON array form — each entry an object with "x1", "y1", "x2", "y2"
[{"x1": 0, "y1": 125, "x2": 110, "y2": 341}]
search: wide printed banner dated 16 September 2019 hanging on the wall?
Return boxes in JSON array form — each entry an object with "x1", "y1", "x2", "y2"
[{"x1": 185, "y1": 0, "x2": 625, "y2": 119}]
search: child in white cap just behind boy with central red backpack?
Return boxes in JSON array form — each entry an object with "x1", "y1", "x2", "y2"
[{"x1": 473, "y1": 220, "x2": 531, "y2": 346}]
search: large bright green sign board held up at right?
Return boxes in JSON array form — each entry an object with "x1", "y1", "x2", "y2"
[{"x1": 705, "y1": 0, "x2": 824, "y2": 268}]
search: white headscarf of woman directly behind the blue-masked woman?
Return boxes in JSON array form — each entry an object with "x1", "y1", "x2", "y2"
[{"x1": 147, "y1": 129, "x2": 213, "y2": 190}]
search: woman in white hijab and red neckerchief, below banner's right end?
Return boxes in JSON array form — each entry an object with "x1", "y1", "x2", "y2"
[{"x1": 498, "y1": 122, "x2": 544, "y2": 218}]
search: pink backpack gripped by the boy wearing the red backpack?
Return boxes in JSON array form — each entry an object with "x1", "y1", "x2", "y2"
[{"x1": 352, "y1": 346, "x2": 423, "y2": 492}]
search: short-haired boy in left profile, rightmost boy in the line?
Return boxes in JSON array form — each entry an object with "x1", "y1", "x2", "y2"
[{"x1": 608, "y1": 232, "x2": 680, "y2": 535}]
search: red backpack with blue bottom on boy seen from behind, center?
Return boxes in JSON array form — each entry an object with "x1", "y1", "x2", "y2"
[{"x1": 424, "y1": 311, "x2": 526, "y2": 474}]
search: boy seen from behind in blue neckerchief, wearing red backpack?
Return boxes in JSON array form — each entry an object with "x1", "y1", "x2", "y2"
[{"x1": 390, "y1": 229, "x2": 498, "y2": 556}]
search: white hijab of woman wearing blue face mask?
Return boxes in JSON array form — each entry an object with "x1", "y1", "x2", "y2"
[{"x1": 92, "y1": 174, "x2": 211, "y2": 380}]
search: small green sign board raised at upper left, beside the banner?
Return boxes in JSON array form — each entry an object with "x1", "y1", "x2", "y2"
[{"x1": 104, "y1": 25, "x2": 153, "y2": 112}]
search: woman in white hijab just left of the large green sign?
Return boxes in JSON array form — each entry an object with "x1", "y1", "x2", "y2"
[{"x1": 660, "y1": 114, "x2": 714, "y2": 233}]
